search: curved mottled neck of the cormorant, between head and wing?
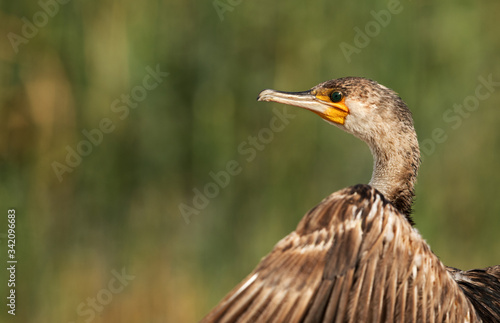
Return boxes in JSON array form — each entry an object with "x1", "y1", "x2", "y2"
[{"x1": 368, "y1": 127, "x2": 420, "y2": 224}]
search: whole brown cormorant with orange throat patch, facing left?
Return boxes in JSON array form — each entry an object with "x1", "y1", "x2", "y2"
[{"x1": 202, "y1": 78, "x2": 500, "y2": 322}]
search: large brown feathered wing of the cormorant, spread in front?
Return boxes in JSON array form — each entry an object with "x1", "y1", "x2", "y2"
[{"x1": 202, "y1": 185, "x2": 477, "y2": 322}]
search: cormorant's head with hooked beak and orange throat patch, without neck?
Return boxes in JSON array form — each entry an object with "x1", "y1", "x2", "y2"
[{"x1": 258, "y1": 77, "x2": 413, "y2": 146}]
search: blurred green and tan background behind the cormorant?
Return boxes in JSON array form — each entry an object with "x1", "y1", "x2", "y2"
[{"x1": 0, "y1": 0, "x2": 500, "y2": 322}]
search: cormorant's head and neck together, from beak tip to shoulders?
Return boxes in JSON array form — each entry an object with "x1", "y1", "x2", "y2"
[{"x1": 258, "y1": 77, "x2": 420, "y2": 223}]
